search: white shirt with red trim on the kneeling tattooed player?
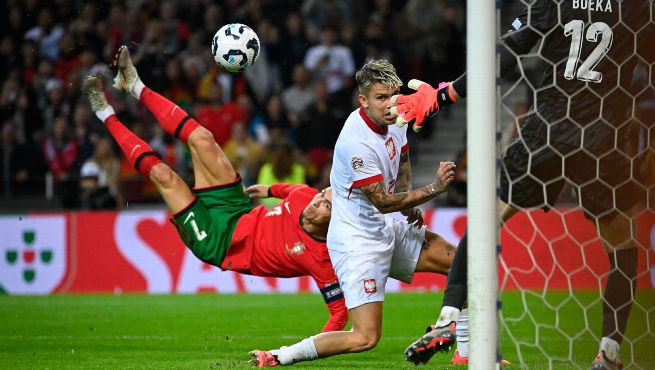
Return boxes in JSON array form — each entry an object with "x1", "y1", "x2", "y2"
[{"x1": 327, "y1": 108, "x2": 408, "y2": 252}]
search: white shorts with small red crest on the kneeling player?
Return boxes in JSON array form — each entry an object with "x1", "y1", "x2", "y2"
[{"x1": 328, "y1": 218, "x2": 425, "y2": 309}]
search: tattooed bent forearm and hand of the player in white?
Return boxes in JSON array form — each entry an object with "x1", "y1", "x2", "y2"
[{"x1": 360, "y1": 162, "x2": 455, "y2": 213}]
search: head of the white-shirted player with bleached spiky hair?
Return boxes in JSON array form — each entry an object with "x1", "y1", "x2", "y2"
[{"x1": 355, "y1": 59, "x2": 403, "y2": 126}]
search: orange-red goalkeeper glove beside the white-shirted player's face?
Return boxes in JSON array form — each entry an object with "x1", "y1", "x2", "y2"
[{"x1": 390, "y1": 79, "x2": 450, "y2": 132}]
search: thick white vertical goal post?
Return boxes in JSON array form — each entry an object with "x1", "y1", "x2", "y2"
[{"x1": 466, "y1": 0, "x2": 498, "y2": 369}]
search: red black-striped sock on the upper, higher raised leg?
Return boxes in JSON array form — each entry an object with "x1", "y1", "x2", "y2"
[{"x1": 139, "y1": 87, "x2": 200, "y2": 143}]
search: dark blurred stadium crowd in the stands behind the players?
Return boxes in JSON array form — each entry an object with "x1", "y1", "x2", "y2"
[{"x1": 0, "y1": 0, "x2": 465, "y2": 209}]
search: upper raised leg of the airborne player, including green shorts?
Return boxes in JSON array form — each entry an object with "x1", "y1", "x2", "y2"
[{"x1": 114, "y1": 46, "x2": 252, "y2": 266}]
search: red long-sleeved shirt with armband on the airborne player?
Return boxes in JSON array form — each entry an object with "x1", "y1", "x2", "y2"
[{"x1": 221, "y1": 184, "x2": 348, "y2": 331}]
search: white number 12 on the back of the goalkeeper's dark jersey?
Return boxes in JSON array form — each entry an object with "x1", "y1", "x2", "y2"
[{"x1": 564, "y1": 19, "x2": 614, "y2": 83}]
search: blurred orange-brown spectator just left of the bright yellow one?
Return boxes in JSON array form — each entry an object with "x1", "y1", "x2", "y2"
[{"x1": 223, "y1": 122, "x2": 263, "y2": 186}]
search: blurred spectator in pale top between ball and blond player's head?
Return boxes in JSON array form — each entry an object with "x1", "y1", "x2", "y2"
[{"x1": 304, "y1": 27, "x2": 355, "y2": 93}]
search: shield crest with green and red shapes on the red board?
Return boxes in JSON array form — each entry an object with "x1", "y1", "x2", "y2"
[{"x1": 0, "y1": 216, "x2": 66, "y2": 294}]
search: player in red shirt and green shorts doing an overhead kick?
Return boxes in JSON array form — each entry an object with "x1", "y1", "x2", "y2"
[{"x1": 82, "y1": 47, "x2": 348, "y2": 331}]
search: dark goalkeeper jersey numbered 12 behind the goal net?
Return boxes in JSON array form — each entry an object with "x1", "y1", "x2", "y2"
[{"x1": 501, "y1": 0, "x2": 655, "y2": 150}]
